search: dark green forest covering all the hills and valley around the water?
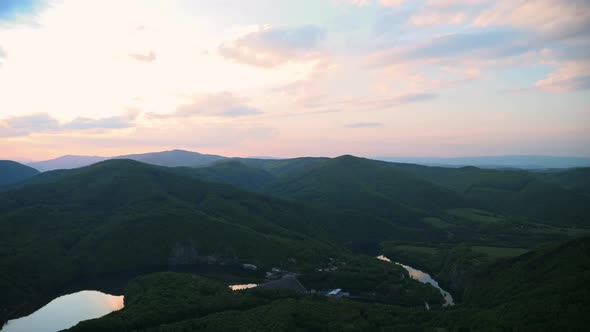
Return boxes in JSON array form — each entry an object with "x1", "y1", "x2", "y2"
[{"x1": 0, "y1": 156, "x2": 590, "y2": 331}]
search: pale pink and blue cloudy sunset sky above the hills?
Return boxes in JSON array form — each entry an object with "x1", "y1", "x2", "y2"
[{"x1": 0, "y1": 0, "x2": 590, "y2": 160}]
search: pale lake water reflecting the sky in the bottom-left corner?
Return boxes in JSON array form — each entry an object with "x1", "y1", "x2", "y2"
[{"x1": 0, "y1": 291, "x2": 123, "y2": 332}]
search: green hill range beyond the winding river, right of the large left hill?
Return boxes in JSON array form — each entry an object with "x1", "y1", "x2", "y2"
[{"x1": 143, "y1": 156, "x2": 585, "y2": 253}]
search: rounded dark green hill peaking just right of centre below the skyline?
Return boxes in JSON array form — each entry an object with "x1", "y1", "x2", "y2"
[{"x1": 265, "y1": 156, "x2": 468, "y2": 222}]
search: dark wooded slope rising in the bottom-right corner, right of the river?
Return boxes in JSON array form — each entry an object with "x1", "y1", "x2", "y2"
[{"x1": 464, "y1": 237, "x2": 590, "y2": 331}]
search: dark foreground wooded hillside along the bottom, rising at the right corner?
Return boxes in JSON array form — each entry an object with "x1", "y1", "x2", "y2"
[{"x1": 70, "y1": 238, "x2": 590, "y2": 331}]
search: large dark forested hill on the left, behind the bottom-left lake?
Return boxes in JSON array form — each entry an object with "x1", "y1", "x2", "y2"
[{"x1": 0, "y1": 160, "x2": 339, "y2": 320}]
